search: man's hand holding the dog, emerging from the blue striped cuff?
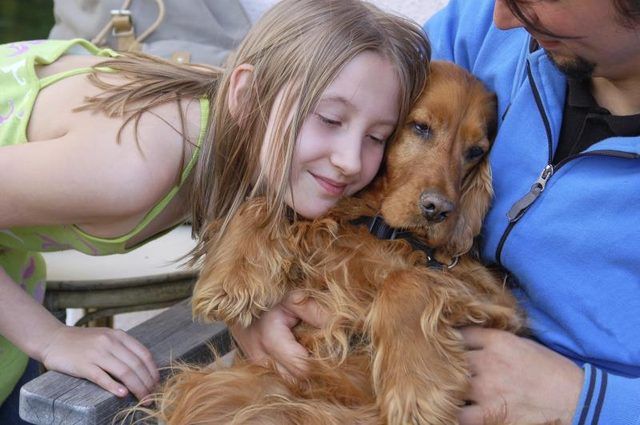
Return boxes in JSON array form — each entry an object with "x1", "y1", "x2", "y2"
[{"x1": 459, "y1": 327, "x2": 584, "y2": 425}]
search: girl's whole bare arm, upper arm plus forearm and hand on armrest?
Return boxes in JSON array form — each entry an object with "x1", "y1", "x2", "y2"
[{"x1": 0, "y1": 99, "x2": 195, "y2": 398}]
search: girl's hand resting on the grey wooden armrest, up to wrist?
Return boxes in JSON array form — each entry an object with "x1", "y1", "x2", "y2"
[{"x1": 39, "y1": 326, "x2": 160, "y2": 399}]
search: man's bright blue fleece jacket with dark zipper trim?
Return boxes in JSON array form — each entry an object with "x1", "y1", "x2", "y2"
[{"x1": 425, "y1": 0, "x2": 640, "y2": 425}]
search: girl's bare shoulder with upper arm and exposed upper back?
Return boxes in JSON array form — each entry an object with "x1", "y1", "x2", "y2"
[{"x1": 0, "y1": 57, "x2": 201, "y2": 235}]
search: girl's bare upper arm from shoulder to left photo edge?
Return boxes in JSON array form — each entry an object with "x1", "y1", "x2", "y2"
[{"x1": 0, "y1": 92, "x2": 200, "y2": 229}]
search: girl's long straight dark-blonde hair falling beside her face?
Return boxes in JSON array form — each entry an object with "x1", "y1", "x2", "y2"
[{"x1": 81, "y1": 0, "x2": 430, "y2": 259}]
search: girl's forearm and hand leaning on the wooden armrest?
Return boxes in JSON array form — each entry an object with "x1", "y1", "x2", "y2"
[{"x1": 0, "y1": 268, "x2": 159, "y2": 399}]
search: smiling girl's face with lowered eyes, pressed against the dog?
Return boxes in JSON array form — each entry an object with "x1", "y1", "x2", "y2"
[{"x1": 261, "y1": 52, "x2": 400, "y2": 218}]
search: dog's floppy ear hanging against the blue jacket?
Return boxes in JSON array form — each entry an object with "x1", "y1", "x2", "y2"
[{"x1": 447, "y1": 156, "x2": 493, "y2": 256}]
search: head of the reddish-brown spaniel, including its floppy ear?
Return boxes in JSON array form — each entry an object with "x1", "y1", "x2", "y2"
[{"x1": 381, "y1": 62, "x2": 496, "y2": 255}]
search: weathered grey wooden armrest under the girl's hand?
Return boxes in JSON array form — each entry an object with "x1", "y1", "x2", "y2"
[{"x1": 20, "y1": 300, "x2": 231, "y2": 425}]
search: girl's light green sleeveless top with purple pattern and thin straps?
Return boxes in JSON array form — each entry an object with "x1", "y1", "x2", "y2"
[{"x1": 0, "y1": 39, "x2": 209, "y2": 404}]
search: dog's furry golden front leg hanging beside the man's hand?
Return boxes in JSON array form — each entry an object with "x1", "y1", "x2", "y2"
[{"x1": 367, "y1": 270, "x2": 467, "y2": 425}]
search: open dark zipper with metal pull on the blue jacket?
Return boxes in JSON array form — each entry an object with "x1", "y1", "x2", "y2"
[{"x1": 496, "y1": 62, "x2": 640, "y2": 266}]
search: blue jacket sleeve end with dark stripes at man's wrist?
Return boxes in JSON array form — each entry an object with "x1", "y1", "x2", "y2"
[{"x1": 573, "y1": 363, "x2": 640, "y2": 425}]
